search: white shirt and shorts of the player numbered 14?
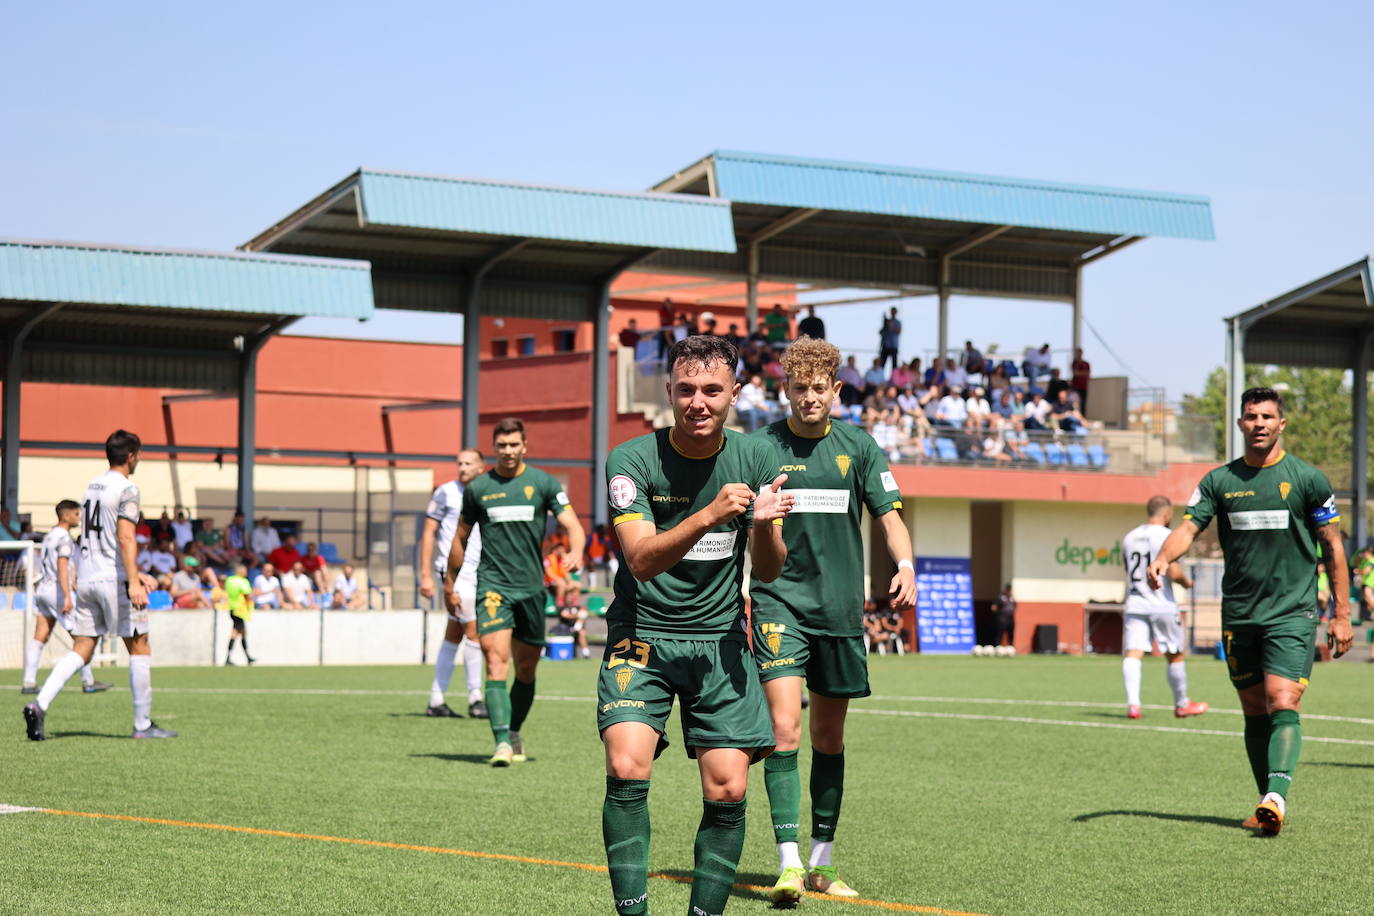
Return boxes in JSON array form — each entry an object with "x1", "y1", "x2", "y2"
[{"x1": 71, "y1": 470, "x2": 148, "y2": 639}]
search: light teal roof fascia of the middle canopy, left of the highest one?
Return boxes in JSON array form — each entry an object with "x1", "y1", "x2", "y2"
[{"x1": 359, "y1": 169, "x2": 735, "y2": 253}]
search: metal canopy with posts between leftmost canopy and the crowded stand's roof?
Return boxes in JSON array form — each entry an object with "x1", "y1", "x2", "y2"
[{"x1": 243, "y1": 169, "x2": 735, "y2": 522}]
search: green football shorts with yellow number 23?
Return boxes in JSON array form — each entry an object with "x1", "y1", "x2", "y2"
[{"x1": 596, "y1": 629, "x2": 774, "y2": 761}]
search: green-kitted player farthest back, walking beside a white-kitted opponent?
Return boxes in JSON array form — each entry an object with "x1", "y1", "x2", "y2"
[{"x1": 444, "y1": 417, "x2": 584, "y2": 766}]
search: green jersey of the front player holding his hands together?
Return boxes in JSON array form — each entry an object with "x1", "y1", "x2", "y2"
[{"x1": 607, "y1": 430, "x2": 778, "y2": 640}]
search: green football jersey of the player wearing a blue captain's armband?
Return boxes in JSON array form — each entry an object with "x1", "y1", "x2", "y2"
[{"x1": 1183, "y1": 453, "x2": 1340, "y2": 626}]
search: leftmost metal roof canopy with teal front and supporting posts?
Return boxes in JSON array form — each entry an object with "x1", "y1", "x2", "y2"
[{"x1": 0, "y1": 239, "x2": 372, "y2": 527}]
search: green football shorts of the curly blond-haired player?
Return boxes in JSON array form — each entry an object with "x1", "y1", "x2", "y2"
[{"x1": 754, "y1": 623, "x2": 872, "y2": 699}]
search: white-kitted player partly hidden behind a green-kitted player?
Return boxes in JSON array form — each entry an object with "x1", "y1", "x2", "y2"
[{"x1": 420, "y1": 449, "x2": 486, "y2": 718}]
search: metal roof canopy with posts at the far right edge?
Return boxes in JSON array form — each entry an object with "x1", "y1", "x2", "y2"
[{"x1": 1224, "y1": 255, "x2": 1374, "y2": 549}]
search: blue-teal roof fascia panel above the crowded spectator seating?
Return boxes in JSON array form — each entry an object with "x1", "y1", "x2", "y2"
[{"x1": 712, "y1": 151, "x2": 1215, "y2": 240}]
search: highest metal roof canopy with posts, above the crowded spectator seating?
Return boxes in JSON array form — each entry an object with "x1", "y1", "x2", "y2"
[{"x1": 642, "y1": 151, "x2": 1215, "y2": 353}]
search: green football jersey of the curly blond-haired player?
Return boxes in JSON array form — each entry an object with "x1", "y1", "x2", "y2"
[{"x1": 749, "y1": 420, "x2": 901, "y2": 636}]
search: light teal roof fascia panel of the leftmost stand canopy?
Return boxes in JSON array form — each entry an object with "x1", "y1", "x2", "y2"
[{"x1": 0, "y1": 239, "x2": 372, "y2": 319}]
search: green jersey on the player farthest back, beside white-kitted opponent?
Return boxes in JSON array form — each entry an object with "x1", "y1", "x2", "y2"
[{"x1": 460, "y1": 464, "x2": 573, "y2": 596}]
